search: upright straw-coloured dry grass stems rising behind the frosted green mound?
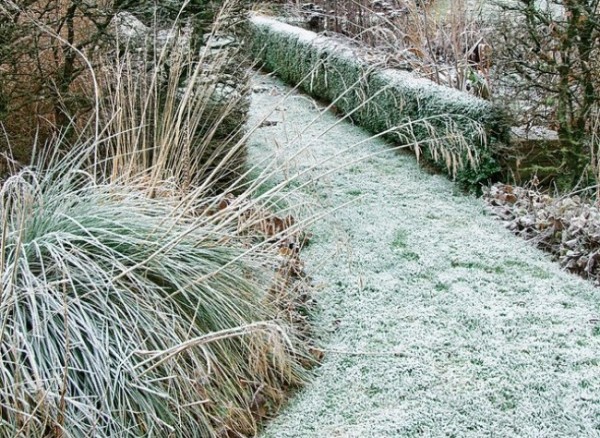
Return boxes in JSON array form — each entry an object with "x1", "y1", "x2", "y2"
[{"x1": 97, "y1": 1, "x2": 250, "y2": 195}]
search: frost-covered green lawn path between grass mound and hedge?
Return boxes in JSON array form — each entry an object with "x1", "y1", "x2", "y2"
[{"x1": 249, "y1": 75, "x2": 600, "y2": 438}]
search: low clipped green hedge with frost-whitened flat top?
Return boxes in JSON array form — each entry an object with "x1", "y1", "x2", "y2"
[{"x1": 250, "y1": 16, "x2": 509, "y2": 185}]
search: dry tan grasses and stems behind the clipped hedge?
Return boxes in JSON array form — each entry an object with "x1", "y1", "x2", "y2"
[{"x1": 290, "y1": 0, "x2": 493, "y2": 95}]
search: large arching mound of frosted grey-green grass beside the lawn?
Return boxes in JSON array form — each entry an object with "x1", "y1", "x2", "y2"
[{"x1": 0, "y1": 146, "x2": 304, "y2": 437}]
